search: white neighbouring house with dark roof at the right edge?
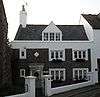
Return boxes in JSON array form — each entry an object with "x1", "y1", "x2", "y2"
[{"x1": 80, "y1": 13, "x2": 100, "y2": 82}]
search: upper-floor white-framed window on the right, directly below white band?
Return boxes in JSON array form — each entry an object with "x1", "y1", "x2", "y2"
[{"x1": 73, "y1": 50, "x2": 88, "y2": 60}]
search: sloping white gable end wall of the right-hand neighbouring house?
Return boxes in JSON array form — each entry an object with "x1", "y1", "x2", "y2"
[{"x1": 80, "y1": 15, "x2": 94, "y2": 41}]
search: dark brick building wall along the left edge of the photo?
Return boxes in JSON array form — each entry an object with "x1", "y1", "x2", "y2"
[{"x1": 0, "y1": 0, "x2": 11, "y2": 87}]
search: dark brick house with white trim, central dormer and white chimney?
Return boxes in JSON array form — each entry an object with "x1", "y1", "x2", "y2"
[{"x1": 11, "y1": 6, "x2": 98, "y2": 90}]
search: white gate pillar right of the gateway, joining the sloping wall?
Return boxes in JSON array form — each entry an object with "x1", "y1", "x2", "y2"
[{"x1": 43, "y1": 75, "x2": 52, "y2": 96}]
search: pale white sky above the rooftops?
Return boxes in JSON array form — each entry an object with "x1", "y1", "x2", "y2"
[{"x1": 3, "y1": 0, "x2": 100, "y2": 41}]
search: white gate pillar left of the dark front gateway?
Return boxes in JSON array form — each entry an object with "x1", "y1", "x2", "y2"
[{"x1": 25, "y1": 76, "x2": 36, "y2": 97}]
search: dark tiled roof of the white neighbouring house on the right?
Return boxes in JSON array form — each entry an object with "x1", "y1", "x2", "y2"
[{"x1": 82, "y1": 14, "x2": 100, "y2": 29}]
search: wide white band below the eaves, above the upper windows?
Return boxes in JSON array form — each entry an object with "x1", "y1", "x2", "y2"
[{"x1": 11, "y1": 41, "x2": 92, "y2": 50}]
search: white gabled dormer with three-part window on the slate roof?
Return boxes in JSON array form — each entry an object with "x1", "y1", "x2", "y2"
[{"x1": 42, "y1": 21, "x2": 62, "y2": 42}]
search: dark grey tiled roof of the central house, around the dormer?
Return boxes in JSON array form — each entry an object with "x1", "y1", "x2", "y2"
[{"x1": 14, "y1": 25, "x2": 88, "y2": 41}]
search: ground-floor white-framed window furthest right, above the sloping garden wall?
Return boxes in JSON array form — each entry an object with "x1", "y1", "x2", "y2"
[{"x1": 73, "y1": 68, "x2": 88, "y2": 80}]
